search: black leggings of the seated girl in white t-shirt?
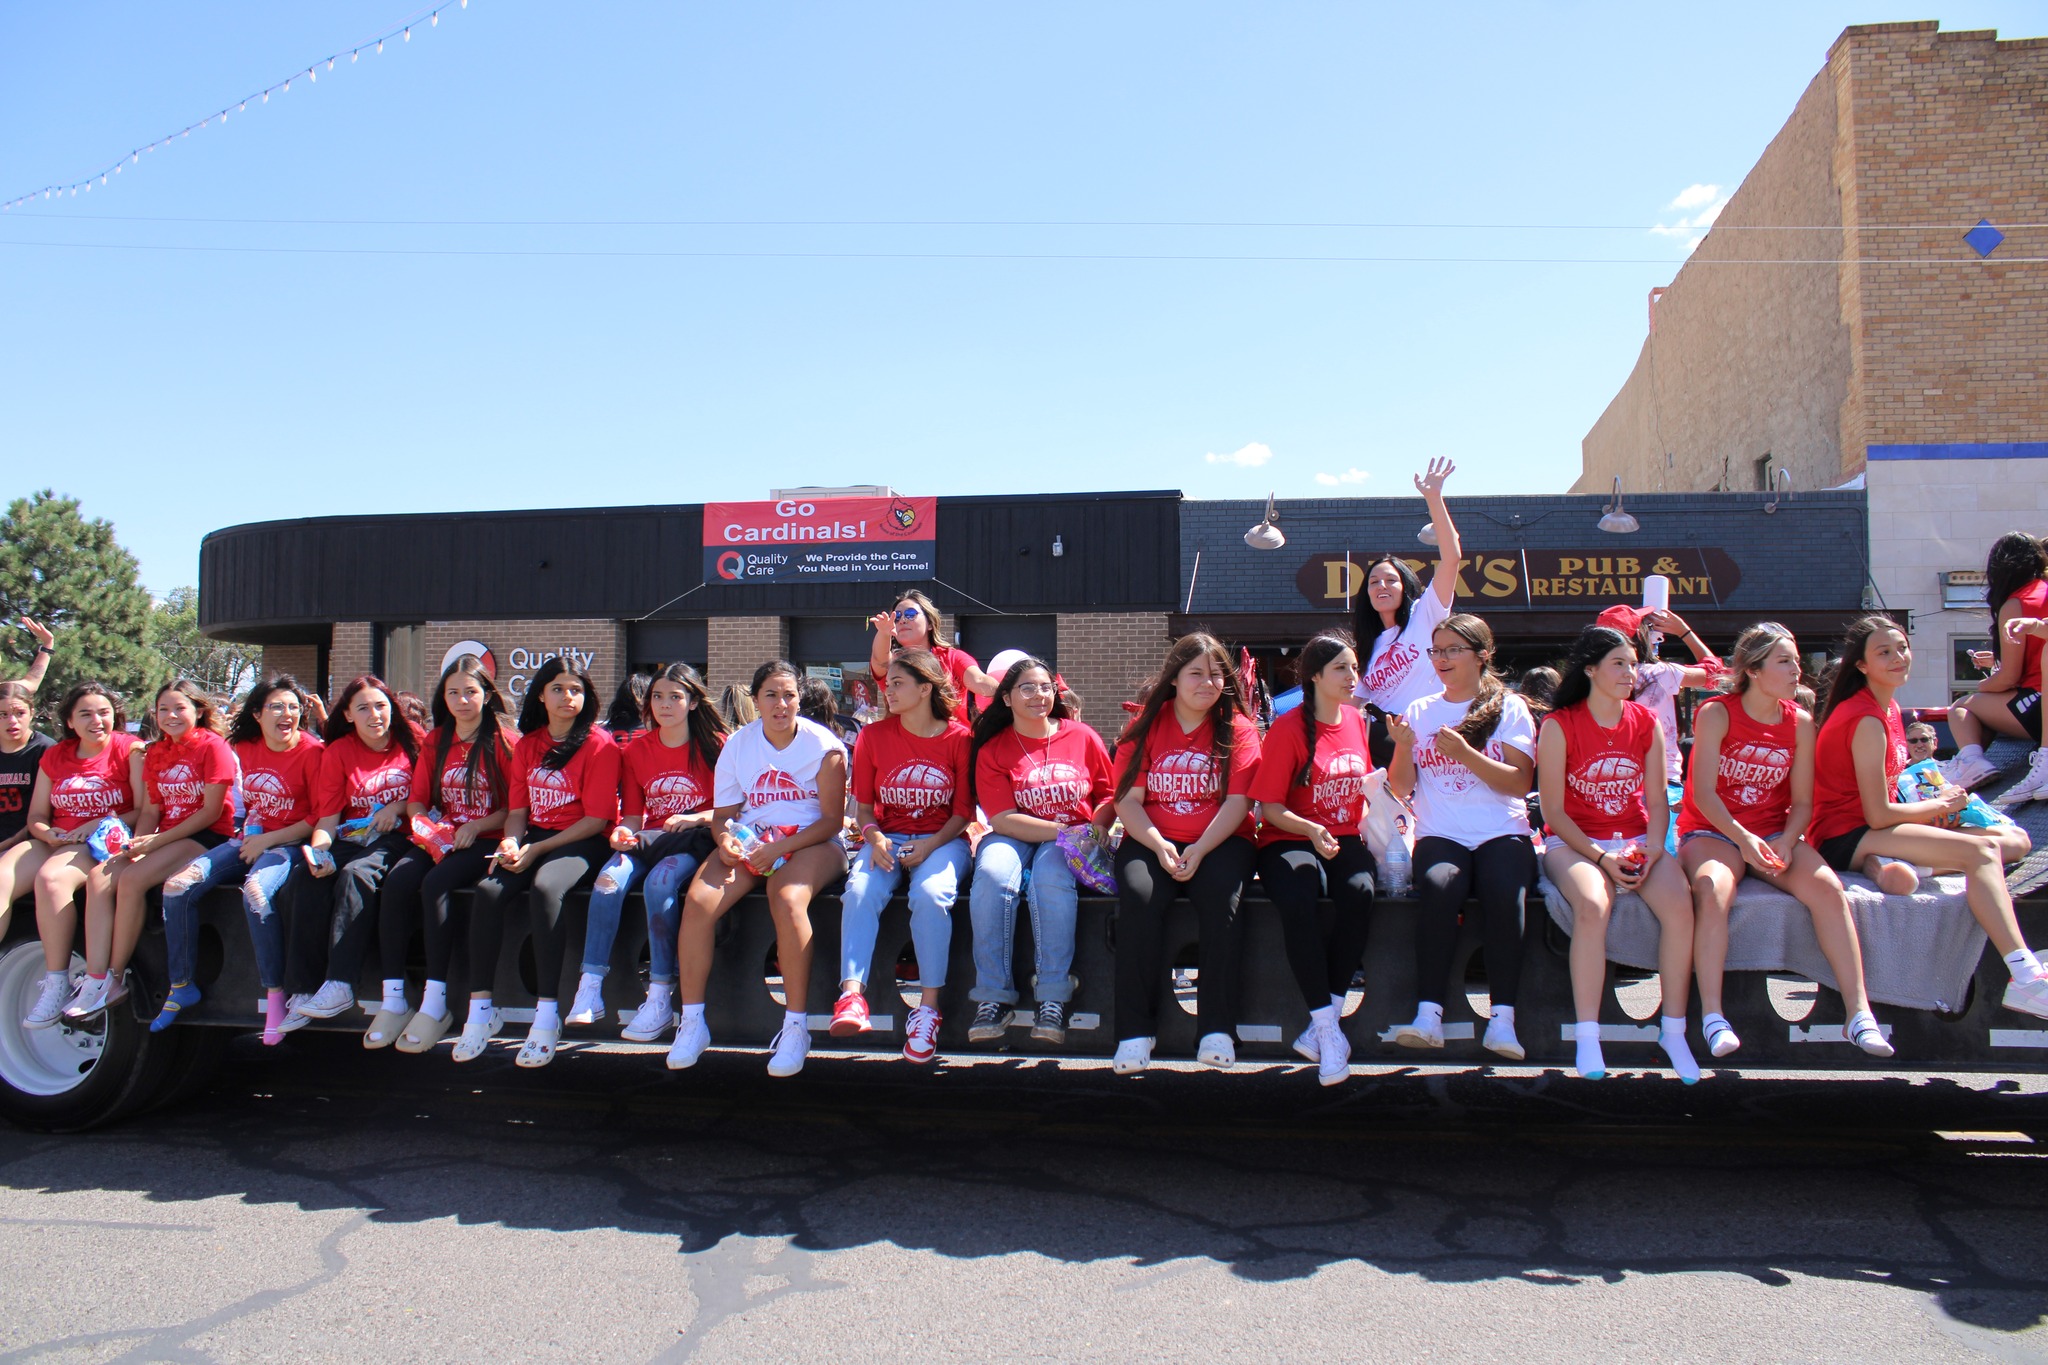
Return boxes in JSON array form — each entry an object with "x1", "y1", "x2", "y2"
[{"x1": 1415, "y1": 835, "x2": 1536, "y2": 1005}]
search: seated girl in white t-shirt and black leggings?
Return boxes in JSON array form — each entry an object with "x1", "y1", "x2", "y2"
[{"x1": 1386, "y1": 612, "x2": 1536, "y2": 1062}]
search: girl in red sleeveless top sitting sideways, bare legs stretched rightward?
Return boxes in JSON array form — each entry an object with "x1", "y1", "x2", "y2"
[{"x1": 1806, "y1": 616, "x2": 2048, "y2": 1019}]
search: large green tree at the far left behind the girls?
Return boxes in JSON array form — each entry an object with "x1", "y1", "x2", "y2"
[{"x1": 0, "y1": 489, "x2": 170, "y2": 718}]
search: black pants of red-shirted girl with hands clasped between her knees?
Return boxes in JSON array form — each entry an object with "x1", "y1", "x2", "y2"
[{"x1": 1116, "y1": 837, "x2": 1253, "y2": 1040}]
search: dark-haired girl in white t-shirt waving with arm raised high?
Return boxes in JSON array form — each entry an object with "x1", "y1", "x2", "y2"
[{"x1": 1352, "y1": 460, "x2": 1462, "y2": 767}]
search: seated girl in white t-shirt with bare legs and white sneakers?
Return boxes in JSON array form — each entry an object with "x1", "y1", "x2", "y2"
[{"x1": 668, "y1": 659, "x2": 846, "y2": 1076}]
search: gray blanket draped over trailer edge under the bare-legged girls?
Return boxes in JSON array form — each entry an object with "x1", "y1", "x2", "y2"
[{"x1": 1542, "y1": 874, "x2": 1985, "y2": 1011}]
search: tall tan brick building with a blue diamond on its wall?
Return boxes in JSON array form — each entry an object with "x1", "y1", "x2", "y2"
[{"x1": 1573, "y1": 23, "x2": 2048, "y2": 706}]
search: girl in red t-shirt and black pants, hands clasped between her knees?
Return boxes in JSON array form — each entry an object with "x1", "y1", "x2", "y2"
[{"x1": 1112, "y1": 634, "x2": 1260, "y2": 1074}]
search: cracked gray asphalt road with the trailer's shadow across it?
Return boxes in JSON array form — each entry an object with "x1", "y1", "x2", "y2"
[{"x1": 0, "y1": 1036, "x2": 2048, "y2": 1365}]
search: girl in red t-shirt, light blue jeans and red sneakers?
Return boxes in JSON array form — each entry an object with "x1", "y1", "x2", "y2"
[{"x1": 831, "y1": 649, "x2": 975, "y2": 1062}]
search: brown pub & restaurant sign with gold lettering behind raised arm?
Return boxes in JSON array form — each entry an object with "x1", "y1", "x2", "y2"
[{"x1": 1294, "y1": 548, "x2": 1743, "y2": 610}]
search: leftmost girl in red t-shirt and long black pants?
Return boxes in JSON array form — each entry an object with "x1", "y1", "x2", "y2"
[{"x1": 283, "y1": 673, "x2": 426, "y2": 1031}]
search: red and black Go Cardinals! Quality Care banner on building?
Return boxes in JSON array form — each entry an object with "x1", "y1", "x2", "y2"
[{"x1": 705, "y1": 497, "x2": 938, "y2": 583}]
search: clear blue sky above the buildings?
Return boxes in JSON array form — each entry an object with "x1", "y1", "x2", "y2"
[{"x1": 0, "y1": 0, "x2": 2048, "y2": 593}]
